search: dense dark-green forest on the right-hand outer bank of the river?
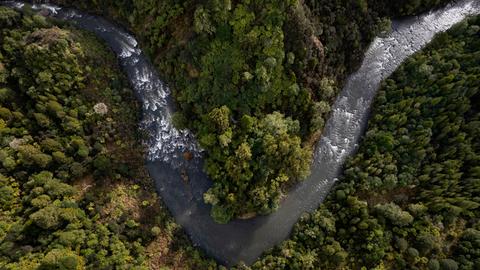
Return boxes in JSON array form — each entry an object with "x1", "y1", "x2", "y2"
[{"x1": 252, "y1": 16, "x2": 480, "y2": 270}]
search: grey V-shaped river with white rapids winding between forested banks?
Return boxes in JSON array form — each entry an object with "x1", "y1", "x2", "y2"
[{"x1": 2, "y1": 0, "x2": 480, "y2": 265}]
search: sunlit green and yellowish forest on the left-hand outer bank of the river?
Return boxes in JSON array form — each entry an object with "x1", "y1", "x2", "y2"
[{"x1": 0, "y1": 7, "x2": 215, "y2": 270}]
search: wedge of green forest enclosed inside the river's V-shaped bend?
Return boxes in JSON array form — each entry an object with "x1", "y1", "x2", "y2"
[{"x1": 55, "y1": 0, "x2": 454, "y2": 222}]
